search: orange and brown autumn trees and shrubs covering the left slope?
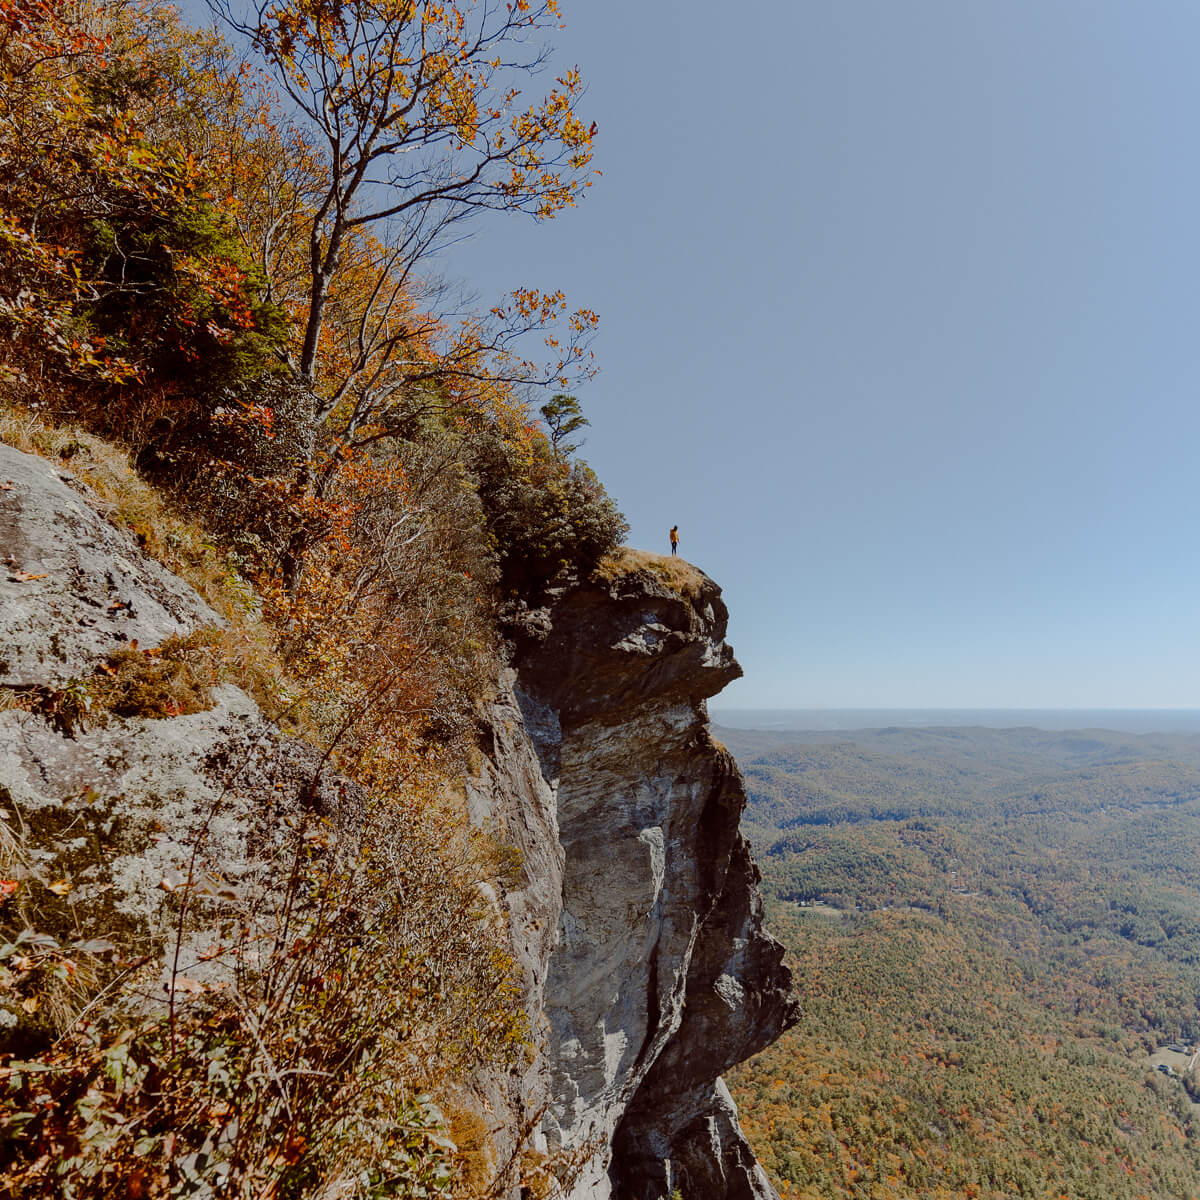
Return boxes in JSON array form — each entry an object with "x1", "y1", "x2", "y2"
[{"x1": 0, "y1": 0, "x2": 625, "y2": 1198}]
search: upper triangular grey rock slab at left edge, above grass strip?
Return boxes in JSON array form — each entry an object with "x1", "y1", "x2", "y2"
[{"x1": 0, "y1": 444, "x2": 220, "y2": 688}]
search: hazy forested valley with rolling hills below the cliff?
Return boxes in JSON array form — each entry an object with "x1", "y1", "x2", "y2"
[{"x1": 719, "y1": 728, "x2": 1200, "y2": 1200}]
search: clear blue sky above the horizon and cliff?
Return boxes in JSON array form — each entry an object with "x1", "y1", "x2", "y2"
[{"x1": 182, "y1": 0, "x2": 1200, "y2": 708}]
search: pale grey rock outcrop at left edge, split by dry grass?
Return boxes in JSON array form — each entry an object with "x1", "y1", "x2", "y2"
[{"x1": 0, "y1": 445, "x2": 360, "y2": 1008}]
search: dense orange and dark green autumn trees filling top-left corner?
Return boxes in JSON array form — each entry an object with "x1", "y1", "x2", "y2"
[{"x1": 0, "y1": 0, "x2": 283, "y2": 408}]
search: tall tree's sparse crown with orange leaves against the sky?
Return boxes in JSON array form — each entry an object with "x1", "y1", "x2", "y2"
[{"x1": 209, "y1": 0, "x2": 595, "y2": 437}]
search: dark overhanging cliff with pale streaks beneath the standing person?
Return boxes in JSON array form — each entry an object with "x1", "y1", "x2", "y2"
[{"x1": 492, "y1": 571, "x2": 794, "y2": 1200}]
